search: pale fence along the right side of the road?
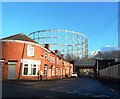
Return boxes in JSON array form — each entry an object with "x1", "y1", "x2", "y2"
[{"x1": 99, "y1": 64, "x2": 120, "y2": 80}]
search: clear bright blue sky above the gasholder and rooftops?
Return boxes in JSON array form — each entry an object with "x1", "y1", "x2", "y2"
[{"x1": 2, "y1": 2, "x2": 118, "y2": 52}]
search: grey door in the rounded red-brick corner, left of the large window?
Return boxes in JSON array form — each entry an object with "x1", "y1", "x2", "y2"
[{"x1": 8, "y1": 62, "x2": 17, "y2": 80}]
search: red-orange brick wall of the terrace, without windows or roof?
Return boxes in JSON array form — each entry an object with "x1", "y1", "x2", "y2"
[{"x1": 2, "y1": 40, "x2": 73, "y2": 80}]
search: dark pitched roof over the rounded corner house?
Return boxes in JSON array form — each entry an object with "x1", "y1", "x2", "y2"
[{"x1": 2, "y1": 33, "x2": 37, "y2": 43}]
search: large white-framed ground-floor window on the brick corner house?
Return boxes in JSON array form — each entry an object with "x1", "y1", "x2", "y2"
[{"x1": 23, "y1": 64, "x2": 39, "y2": 76}]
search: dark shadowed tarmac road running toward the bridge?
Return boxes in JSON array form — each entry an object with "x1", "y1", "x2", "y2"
[{"x1": 2, "y1": 77, "x2": 120, "y2": 99}]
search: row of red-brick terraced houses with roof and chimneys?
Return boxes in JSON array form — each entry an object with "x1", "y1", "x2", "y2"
[{"x1": 0, "y1": 33, "x2": 73, "y2": 80}]
